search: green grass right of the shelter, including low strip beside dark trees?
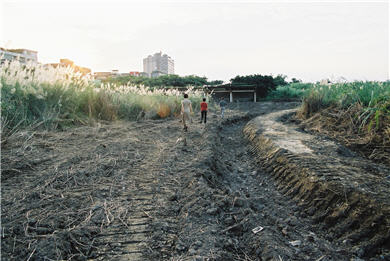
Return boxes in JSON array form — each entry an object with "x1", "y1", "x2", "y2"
[{"x1": 267, "y1": 81, "x2": 390, "y2": 130}]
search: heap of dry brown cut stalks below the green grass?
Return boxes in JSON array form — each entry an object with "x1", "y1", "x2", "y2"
[{"x1": 295, "y1": 104, "x2": 390, "y2": 167}]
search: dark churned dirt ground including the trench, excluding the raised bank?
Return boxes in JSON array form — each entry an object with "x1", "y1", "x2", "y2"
[{"x1": 1, "y1": 103, "x2": 389, "y2": 261}]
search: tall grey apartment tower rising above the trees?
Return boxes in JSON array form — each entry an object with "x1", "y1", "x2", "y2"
[{"x1": 144, "y1": 52, "x2": 175, "y2": 77}]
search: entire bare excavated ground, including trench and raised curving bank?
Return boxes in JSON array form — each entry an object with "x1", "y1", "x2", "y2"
[{"x1": 1, "y1": 102, "x2": 390, "y2": 261}]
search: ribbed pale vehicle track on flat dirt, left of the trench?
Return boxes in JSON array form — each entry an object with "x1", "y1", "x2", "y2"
[{"x1": 89, "y1": 127, "x2": 176, "y2": 260}]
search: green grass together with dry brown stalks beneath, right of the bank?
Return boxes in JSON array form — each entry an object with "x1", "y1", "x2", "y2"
[{"x1": 298, "y1": 82, "x2": 390, "y2": 164}]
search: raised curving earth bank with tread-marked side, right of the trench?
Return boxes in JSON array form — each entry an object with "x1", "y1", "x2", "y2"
[{"x1": 244, "y1": 110, "x2": 390, "y2": 260}]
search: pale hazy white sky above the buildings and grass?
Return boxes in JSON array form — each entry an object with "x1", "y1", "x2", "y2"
[{"x1": 0, "y1": 0, "x2": 390, "y2": 82}]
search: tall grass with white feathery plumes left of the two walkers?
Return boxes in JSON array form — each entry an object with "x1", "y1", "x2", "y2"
[{"x1": 0, "y1": 61, "x2": 203, "y2": 135}]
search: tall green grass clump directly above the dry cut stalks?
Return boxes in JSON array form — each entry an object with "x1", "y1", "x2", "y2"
[{"x1": 299, "y1": 81, "x2": 390, "y2": 137}]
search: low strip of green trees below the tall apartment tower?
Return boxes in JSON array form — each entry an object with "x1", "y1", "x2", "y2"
[{"x1": 103, "y1": 74, "x2": 223, "y2": 87}]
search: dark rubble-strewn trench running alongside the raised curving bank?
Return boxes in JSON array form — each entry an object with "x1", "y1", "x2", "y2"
[{"x1": 149, "y1": 114, "x2": 352, "y2": 260}]
